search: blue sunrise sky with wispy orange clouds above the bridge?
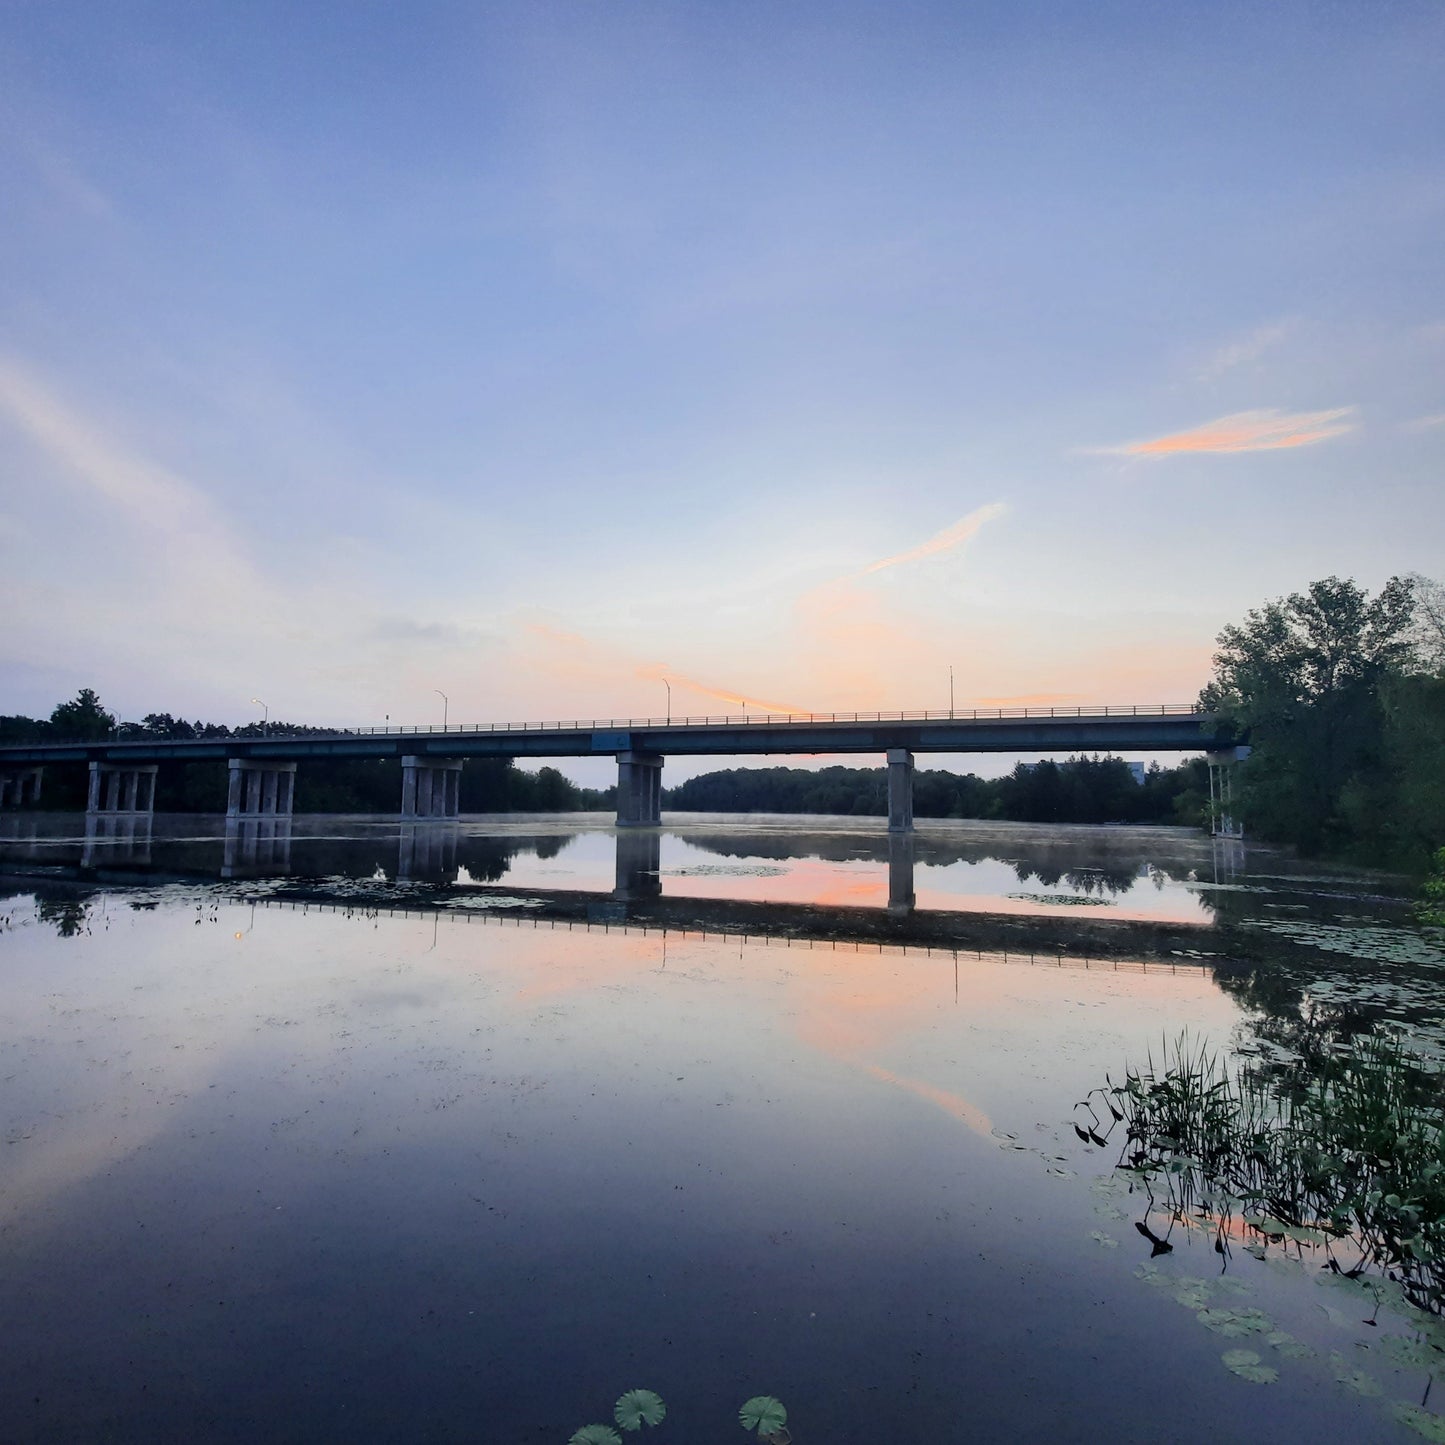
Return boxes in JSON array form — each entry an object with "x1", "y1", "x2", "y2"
[{"x1": 0, "y1": 0, "x2": 1445, "y2": 770}]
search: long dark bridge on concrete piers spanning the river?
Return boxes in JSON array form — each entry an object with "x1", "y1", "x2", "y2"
[{"x1": 0, "y1": 704, "x2": 1235, "y2": 832}]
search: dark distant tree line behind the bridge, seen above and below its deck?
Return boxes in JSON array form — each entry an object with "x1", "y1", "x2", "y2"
[{"x1": 0, "y1": 688, "x2": 1208, "y2": 824}]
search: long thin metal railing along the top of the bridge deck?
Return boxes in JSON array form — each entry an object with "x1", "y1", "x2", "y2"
[{"x1": 14, "y1": 702, "x2": 1205, "y2": 754}]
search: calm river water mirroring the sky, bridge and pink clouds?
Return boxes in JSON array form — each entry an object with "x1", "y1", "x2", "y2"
[{"x1": 0, "y1": 816, "x2": 1445, "y2": 1445}]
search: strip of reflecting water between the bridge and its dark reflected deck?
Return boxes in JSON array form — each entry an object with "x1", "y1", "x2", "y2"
[{"x1": 0, "y1": 814, "x2": 1410, "y2": 946}]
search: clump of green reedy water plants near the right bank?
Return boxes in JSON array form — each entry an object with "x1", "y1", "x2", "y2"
[{"x1": 1078, "y1": 1030, "x2": 1445, "y2": 1315}]
